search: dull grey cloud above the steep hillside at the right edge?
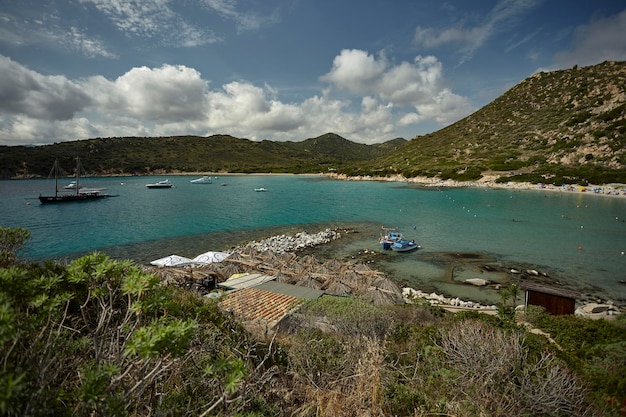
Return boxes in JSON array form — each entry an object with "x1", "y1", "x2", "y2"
[{"x1": 554, "y1": 10, "x2": 626, "y2": 68}]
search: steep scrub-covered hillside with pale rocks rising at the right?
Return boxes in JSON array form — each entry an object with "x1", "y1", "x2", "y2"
[{"x1": 345, "y1": 62, "x2": 626, "y2": 183}]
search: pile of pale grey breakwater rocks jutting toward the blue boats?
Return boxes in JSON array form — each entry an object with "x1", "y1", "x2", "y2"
[{"x1": 233, "y1": 229, "x2": 341, "y2": 254}]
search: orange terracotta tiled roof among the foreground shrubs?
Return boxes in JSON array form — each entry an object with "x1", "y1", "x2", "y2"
[{"x1": 219, "y1": 287, "x2": 300, "y2": 327}]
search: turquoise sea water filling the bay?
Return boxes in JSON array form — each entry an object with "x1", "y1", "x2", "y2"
[{"x1": 0, "y1": 175, "x2": 626, "y2": 305}]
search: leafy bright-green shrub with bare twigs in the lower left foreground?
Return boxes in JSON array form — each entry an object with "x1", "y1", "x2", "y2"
[{"x1": 0, "y1": 253, "x2": 272, "y2": 416}]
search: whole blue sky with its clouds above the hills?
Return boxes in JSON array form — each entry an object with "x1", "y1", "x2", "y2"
[{"x1": 0, "y1": 0, "x2": 626, "y2": 145}]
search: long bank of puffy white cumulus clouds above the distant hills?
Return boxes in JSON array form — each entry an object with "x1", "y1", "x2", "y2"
[{"x1": 0, "y1": 50, "x2": 470, "y2": 144}]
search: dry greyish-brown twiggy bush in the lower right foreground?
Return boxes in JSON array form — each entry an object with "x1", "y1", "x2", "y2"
[{"x1": 440, "y1": 321, "x2": 591, "y2": 416}]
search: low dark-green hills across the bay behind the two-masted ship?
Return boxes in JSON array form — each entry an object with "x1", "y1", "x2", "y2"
[{"x1": 0, "y1": 133, "x2": 406, "y2": 178}]
